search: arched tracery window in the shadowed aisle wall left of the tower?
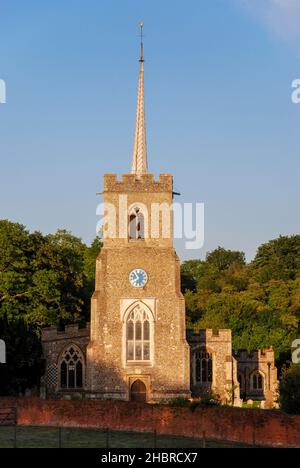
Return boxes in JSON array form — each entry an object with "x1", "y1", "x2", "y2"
[{"x1": 60, "y1": 345, "x2": 84, "y2": 389}]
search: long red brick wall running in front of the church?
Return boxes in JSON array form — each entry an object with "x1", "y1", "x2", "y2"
[{"x1": 0, "y1": 399, "x2": 300, "y2": 447}]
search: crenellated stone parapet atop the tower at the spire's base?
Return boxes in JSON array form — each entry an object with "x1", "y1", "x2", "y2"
[{"x1": 104, "y1": 174, "x2": 173, "y2": 193}]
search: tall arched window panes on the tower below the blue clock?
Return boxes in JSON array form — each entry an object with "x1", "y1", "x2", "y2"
[{"x1": 126, "y1": 304, "x2": 151, "y2": 362}]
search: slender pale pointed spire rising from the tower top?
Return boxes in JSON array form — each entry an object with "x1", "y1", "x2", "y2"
[{"x1": 131, "y1": 22, "x2": 148, "y2": 176}]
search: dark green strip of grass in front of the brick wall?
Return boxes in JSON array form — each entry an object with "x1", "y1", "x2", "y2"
[{"x1": 0, "y1": 426, "x2": 256, "y2": 448}]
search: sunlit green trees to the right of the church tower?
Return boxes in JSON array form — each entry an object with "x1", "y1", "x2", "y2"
[{"x1": 182, "y1": 236, "x2": 300, "y2": 364}]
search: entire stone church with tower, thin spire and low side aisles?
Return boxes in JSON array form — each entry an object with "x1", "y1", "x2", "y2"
[{"x1": 42, "y1": 31, "x2": 277, "y2": 407}]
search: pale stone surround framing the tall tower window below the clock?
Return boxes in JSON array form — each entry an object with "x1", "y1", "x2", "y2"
[{"x1": 122, "y1": 299, "x2": 155, "y2": 367}]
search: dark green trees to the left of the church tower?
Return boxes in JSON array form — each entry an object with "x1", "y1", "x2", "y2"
[{"x1": 0, "y1": 220, "x2": 102, "y2": 394}]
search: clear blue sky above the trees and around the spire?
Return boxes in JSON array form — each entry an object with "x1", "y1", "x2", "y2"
[{"x1": 0, "y1": 0, "x2": 300, "y2": 259}]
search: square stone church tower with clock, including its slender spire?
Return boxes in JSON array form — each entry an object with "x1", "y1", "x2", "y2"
[{"x1": 87, "y1": 24, "x2": 190, "y2": 401}]
